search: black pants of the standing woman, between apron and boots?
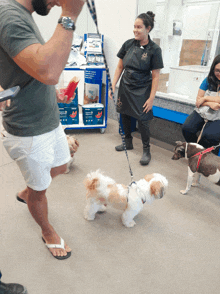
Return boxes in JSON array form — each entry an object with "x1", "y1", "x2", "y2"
[{"x1": 121, "y1": 114, "x2": 150, "y2": 148}]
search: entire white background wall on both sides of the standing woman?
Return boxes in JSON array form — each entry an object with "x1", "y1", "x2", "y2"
[{"x1": 34, "y1": 0, "x2": 219, "y2": 79}]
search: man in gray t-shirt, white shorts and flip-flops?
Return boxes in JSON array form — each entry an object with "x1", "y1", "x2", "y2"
[{"x1": 0, "y1": 0, "x2": 84, "y2": 259}]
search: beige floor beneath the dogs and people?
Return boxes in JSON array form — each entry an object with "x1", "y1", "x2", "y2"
[{"x1": 0, "y1": 119, "x2": 220, "y2": 294}]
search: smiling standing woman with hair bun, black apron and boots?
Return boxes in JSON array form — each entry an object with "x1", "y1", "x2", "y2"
[{"x1": 109, "y1": 11, "x2": 163, "y2": 165}]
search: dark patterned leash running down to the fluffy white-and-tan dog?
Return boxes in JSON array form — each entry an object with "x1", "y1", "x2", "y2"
[{"x1": 86, "y1": 0, "x2": 134, "y2": 185}]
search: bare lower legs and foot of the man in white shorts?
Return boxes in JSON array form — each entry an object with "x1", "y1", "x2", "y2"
[{"x1": 19, "y1": 165, "x2": 71, "y2": 256}]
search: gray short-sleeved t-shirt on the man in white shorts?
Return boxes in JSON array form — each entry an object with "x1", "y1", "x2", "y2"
[{"x1": 0, "y1": 0, "x2": 60, "y2": 137}]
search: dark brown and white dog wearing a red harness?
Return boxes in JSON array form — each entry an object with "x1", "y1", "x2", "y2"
[{"x1": 172, "y1": 141, "x2": 220, "y2": 194}]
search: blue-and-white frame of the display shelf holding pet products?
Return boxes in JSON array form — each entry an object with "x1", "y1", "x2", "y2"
[{"x1": 63, "y1": 67, "x2": 108, "y2": 134}]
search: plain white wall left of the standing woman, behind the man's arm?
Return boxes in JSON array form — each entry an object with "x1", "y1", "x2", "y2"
[{"x1": 33, "y1": 0, "x2": 138, "y2": 85}]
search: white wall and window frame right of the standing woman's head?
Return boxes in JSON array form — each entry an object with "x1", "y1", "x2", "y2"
[{"x1": 147, "y1": 0, "x2": 220, "y2": 73}]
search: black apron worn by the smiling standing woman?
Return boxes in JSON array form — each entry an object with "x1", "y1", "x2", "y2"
[{"x1": 117, "y1": 45, "x2": 153, "y2": 120}]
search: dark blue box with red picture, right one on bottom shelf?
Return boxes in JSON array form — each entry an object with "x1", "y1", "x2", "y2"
[{"x1": 82, "y1": 103, "x2": 104, "y2": 125}]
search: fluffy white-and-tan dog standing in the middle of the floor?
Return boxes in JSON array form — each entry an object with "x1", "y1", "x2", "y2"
[{"x1": 84, "y1": 170, "x2": 168, "y2": 227}]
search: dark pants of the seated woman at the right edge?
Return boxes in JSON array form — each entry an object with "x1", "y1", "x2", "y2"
[{"x1": 182, "y1": 110, "x2": 220, "y2": 155}]
